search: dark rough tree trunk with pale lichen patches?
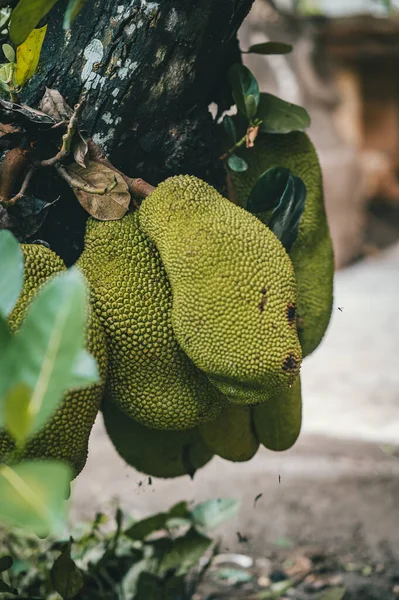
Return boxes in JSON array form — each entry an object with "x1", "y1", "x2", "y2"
[{"x1": 1, "y1": 0, "x2": 253, "y2": 263}]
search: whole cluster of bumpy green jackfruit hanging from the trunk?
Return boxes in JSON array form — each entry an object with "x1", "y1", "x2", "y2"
[{"x1": 0, "y1": 134, "x2": 333, "y2": 477}]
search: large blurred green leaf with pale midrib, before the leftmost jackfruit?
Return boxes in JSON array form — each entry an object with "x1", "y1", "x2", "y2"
[{"x1": 0, "y1": 268, "x2": 87, "y2": 434}]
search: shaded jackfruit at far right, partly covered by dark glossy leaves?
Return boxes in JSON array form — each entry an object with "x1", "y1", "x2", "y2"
[{"x1": 231, "y1": 132, "x2": 334, "y2": 357}]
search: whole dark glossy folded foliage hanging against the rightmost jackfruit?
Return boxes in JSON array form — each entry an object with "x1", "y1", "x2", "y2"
[{"x1": 247, "y1": 167, "x2": 306, "y2": 252}]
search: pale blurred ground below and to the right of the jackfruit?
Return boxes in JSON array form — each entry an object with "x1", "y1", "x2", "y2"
[{"x1": 71, "y1": 244, "x2": 399, "y2": 600}]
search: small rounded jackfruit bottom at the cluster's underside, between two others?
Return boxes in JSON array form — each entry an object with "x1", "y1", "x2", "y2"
[{"x1": 199, "y1": 404, "x2": 260, "y2": 462}]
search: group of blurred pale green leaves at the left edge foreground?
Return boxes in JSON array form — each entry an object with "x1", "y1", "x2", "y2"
[{"x1": 0, "y1": 230, "x2": 98, "y2": 535}]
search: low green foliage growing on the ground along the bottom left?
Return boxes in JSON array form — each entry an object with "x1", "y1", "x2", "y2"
[{"x1": 0, "y1": 499, "x2": 238, "y2": 600}]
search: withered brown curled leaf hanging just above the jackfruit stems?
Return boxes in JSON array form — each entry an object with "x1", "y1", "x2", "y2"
[{"x1": 65, "y1": 161, "x2": 130, "y2": 221}]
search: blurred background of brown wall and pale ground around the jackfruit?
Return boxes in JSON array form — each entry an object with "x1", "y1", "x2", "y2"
[{"x1": 71, "y1": 0, "x2": 399, "y2": 600}]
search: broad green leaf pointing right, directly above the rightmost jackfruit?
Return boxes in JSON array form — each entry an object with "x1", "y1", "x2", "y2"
[{"x1": 256, "y1": 93, "x2": 310, "y2": 133}]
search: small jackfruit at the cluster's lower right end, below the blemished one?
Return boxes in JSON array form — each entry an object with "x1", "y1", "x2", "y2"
[{"x1": 253, "y1": 376, "x2": 302, "y2": 451}]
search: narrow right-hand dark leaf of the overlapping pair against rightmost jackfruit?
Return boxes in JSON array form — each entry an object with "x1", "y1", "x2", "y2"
[{"x1": 268, "y1": 174, "x2": 306, "y2": 252}]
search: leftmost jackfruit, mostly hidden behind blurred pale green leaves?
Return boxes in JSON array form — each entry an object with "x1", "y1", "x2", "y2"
[{"x1": 0, "y1": 244, "x2": 107, "y2": 476}]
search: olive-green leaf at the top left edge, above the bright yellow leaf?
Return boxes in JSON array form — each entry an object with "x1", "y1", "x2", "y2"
[{"x1": 10, "y1": 0, "x2": 57, "y2": 46}]
